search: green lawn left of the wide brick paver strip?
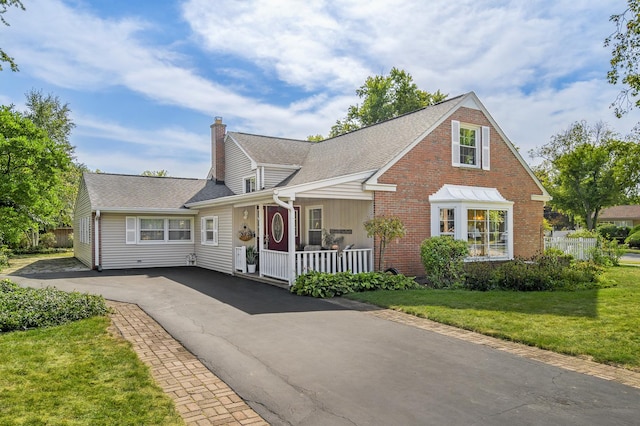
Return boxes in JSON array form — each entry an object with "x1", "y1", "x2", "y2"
[{"x1": 0, "y1": 317, "x2": 184, "y2": 425}]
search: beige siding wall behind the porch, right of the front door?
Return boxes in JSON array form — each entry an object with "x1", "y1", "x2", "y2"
[{"x1": 295, "y1": 198, "x2": 373, "y2": 248}]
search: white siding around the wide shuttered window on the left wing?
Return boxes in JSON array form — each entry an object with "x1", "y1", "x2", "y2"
[{"x1": 100, "y1": 213, "x2": 199, "y2": 269}]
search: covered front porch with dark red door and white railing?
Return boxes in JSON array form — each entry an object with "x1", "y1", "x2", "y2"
[{"x1": 234, "y1": 188, "x2": 374, "y2": 285}]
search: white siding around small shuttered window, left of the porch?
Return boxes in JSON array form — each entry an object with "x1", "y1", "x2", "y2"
[{"x1": 195, "y1": 206, "x2": 235, "y2": 274}]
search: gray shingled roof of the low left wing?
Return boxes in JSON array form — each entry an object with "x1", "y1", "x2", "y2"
[{"x1": 83, "y1": 173, "x2": 233, "y2": 210}]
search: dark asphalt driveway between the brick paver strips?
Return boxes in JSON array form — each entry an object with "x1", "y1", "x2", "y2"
[{"x1": 12, "y1": 267, "x2": 640, "y2": 425}]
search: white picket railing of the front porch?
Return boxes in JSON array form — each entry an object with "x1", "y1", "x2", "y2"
[{"x1": 235, "y1": 246, "x2": 373, "y2": 283}]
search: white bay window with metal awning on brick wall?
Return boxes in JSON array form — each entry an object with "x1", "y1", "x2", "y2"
[{"x1": 429, "y1": 184, "x2": 513, "y2": 260}]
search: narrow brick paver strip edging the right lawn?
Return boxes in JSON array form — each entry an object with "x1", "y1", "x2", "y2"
[{"x1": 333, "y1": 299, "x2": 640, "y2": 389}]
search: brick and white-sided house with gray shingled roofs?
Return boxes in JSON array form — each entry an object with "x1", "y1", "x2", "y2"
[{"x1": 74, "y1": 92, "x2": 550, "y2": 283}]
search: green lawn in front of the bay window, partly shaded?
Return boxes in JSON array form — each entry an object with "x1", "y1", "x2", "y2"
[{"x1": 345, "y1": 266, "x2": 640, "y2": 371}]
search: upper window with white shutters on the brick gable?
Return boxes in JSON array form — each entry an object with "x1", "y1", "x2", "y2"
[{"x1": 451, "y1": 120, "x2": 491, "y2": 170}]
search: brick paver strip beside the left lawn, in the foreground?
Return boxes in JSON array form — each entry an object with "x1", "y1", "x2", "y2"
[{"x1": 108, "y1": 301, "x2": 268, "y2": 426}]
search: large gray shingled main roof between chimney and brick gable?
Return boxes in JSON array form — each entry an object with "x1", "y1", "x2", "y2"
[{"x1": 222, "y1": 96, "x2": 464, "y2": 186}]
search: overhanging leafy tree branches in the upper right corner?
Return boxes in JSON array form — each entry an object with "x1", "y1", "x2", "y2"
[{"x1": 604, "y1": 0, "x2": 640, "y2": 118}]
